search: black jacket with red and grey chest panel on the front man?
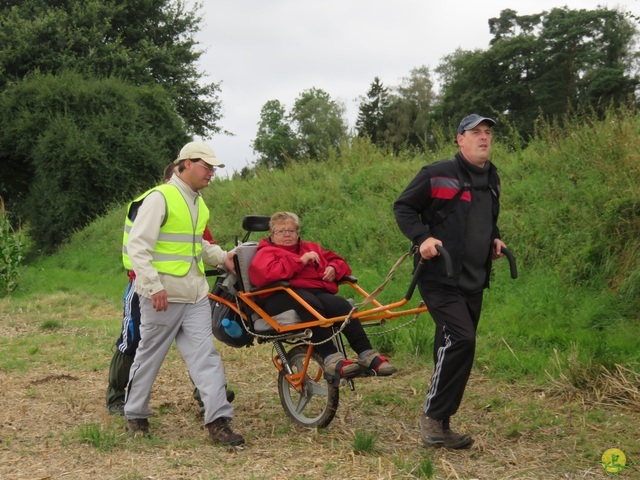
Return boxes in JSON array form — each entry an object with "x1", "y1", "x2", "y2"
[{"x1": 393, "y1": 152, "x2": 500, "y2": 287}]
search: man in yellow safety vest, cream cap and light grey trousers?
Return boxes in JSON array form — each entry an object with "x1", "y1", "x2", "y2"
[{"x1": 123, "y1": 142, "x2": 244, "y2": 445}]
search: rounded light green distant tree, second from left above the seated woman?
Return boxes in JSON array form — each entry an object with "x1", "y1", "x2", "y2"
[{"x1": 289, "y1": 88, "x2": 347, "y2": 160}]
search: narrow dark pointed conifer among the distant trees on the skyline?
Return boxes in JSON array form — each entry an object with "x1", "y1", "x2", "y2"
[{"x1": 356, "y1": 77, "x2": 390, "y2": 146}]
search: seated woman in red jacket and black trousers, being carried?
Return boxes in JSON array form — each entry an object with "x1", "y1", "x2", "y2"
[{"x1": 249, "y1": 212, "x2": 397, "y2": 377}]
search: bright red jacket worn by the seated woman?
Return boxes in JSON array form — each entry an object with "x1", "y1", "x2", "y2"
[{"x1": 249, "y1": 238, "x2": 351, "y2": 293}]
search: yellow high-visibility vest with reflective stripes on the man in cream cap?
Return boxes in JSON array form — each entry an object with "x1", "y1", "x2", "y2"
[{"x1": 122, "y1": 184, "x2": 209, "y2": 277}]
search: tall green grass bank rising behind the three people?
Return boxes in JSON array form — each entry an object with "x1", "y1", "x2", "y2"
[{"x1": 13, "y1": 111, "x2": 640, "y2": 381}]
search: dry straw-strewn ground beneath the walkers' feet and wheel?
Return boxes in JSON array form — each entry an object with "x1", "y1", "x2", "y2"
[{"x1": 0, "y1": 306, "x2": 640, "y2": 480}]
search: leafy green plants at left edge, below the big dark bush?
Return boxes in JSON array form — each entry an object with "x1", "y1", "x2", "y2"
[{"x1": 0, "y1": 197, "x2": 24, "y2": 296}]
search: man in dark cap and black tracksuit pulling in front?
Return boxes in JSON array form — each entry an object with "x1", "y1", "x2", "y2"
[{"x1": 393, "y1": 114, "x2": 505, "y2": 448}]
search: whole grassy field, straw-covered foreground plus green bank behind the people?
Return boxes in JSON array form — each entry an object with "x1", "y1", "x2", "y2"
[{"x1": 0, "y1": 112, "x2": 640, "y2": 480}]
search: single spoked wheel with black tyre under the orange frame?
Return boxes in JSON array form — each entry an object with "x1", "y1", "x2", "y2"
[{"x1": 278, "y1": 345, "x2": 340, "y2": 428}]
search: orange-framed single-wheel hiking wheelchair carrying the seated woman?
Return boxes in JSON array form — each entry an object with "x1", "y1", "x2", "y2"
[{"x1": 209, "y1": 215, "x2": 515, "y2": 428}]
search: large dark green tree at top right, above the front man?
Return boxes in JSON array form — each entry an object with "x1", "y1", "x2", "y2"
[{"x1": 434, "y1": 8, "x2": 639, "y2": 139}]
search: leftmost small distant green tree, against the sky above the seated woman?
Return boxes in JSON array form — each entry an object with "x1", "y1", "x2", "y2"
[{"x1": 253, "y1": 100, "x2": 298, "y2": 169}]
